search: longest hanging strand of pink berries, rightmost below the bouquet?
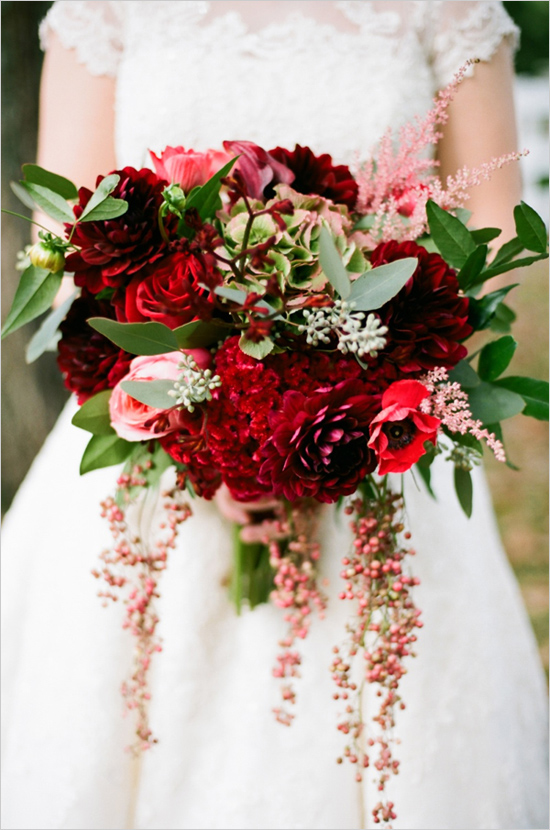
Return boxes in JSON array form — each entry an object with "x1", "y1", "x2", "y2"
[{"x1": 331, "y1": 482, "x2": 422, "y2": 826}]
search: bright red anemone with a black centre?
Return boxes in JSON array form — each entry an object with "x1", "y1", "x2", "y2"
[{"x1": 369, "y1": 380, "x2": 441, "y2": 475}]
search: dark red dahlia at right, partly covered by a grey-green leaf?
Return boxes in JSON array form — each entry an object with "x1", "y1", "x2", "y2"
[{"x1": 371, "y1": 241, "x2": 472, "y2": 373}]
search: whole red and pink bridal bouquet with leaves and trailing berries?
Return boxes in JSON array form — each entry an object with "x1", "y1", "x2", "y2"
[{"x1": 4, "y1": 65, "x2": 548, "y2": 822}]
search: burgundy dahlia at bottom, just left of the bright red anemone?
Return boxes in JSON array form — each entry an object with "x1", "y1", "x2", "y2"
[{"x1": 259, "y1": 380, "x2": 376, "y2": 502}]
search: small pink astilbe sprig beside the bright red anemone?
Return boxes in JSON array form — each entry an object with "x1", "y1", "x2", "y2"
[{"x1": 420, "y1": 368, "x2": 506, "y2": 461}]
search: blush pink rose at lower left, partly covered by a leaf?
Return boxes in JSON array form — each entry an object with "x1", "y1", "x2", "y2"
[{"x1": 109, "y1": 349, "x2": 212, "y2": 441}]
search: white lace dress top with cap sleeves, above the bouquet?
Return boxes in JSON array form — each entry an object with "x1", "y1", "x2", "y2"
[{"x1": 41, "y1": 0, "x2": 517, "y2": 166}]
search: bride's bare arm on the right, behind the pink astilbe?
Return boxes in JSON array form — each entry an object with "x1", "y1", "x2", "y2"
[{"x1": 438, "y1": 40, "x2": 521, "y2": 245}]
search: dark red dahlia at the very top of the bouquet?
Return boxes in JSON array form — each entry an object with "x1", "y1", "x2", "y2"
[{"x1": 269, "y1": 144, "x2": 359, "y2": 209}]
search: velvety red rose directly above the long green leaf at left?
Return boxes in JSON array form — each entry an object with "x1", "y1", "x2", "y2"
[{"x1": 124, "y1": 250, "x2": 216, "y2": 329}]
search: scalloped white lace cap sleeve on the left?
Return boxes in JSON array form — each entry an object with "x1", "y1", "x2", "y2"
[{"x1": 40, "y1": 0, "x2": 123, "y2": 77}]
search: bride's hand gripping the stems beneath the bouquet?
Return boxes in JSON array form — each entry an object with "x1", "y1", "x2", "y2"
[{"x1": 215, "y1": 484, "x2": 285, "y2": 544}]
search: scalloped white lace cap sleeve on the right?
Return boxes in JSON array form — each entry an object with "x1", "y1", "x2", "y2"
[{"x1": 422, "y1": 0, "x2": 519, "y2": 89}]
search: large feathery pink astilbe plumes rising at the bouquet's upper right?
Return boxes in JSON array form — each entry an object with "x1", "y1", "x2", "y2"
[{"x1": 355, "y1": 61, "x2": 527, "y2": 248}]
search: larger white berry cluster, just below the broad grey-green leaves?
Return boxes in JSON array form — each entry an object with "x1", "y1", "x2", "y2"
[{"x1": 300, "y1": 300, "x2": 388, "y2": 357}]
